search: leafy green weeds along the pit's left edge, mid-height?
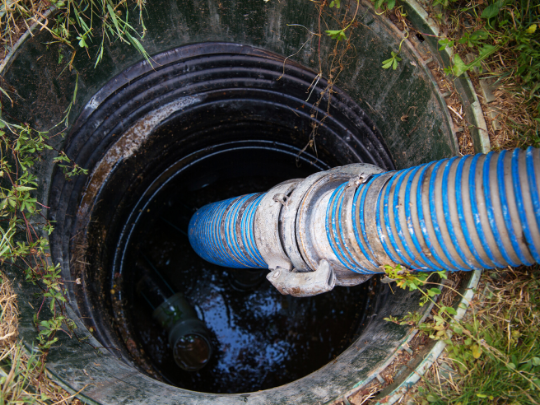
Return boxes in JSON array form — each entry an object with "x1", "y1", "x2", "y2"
[{"x1": 0, "y1": 105, "x2": 86, "y2": 355}]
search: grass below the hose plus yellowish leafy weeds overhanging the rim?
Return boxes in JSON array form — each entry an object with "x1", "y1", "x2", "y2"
[{"x1": 385, "y1": 266, "x2": 540, "y2": 405}]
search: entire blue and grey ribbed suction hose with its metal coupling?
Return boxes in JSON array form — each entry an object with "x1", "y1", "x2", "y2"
[{"x1": 189, "y1": 147, "x2": 540, "y2": 296}]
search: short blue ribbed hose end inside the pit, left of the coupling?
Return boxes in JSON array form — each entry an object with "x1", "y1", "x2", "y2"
[{"x1": 189, "y1": 194, "x2": 268, "y2": 269}]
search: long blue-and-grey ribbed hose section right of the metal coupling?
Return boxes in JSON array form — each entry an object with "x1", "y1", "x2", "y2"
[{"x1": 326, "y1": 148, "x2": 540, "y2": 273}]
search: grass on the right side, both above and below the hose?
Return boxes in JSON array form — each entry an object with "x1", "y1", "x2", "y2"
[{"x1": 390, "y1": 0, "x2": 540, "y2": 405}]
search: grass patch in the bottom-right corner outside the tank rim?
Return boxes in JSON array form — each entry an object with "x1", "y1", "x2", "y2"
[{"x1": 418, "y1": 267, "x2": 540, "y2": 405}]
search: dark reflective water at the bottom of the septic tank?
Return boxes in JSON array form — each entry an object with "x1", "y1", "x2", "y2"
[{"x1": 118, "y1": 157, "x2": 374, "y2": 393}]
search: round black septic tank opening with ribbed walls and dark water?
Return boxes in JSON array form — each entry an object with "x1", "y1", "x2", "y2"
[{"x1": 48, "y1": 43, "x2": 394, "y2": 393}]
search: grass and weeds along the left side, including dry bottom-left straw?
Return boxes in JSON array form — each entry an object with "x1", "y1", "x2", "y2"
[{"x1": 0, "y1": 0, "x2": 149, "y2": 398}]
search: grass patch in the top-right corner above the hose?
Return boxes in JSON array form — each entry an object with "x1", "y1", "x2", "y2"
[{"x1": 433, "y1": 0, "x2": 540, "y2": 149}]
